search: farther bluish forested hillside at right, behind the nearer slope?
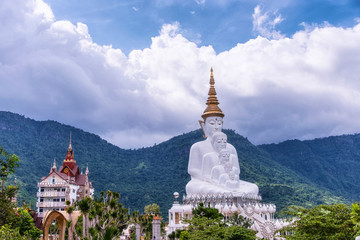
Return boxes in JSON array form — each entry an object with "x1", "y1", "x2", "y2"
[{"x1": 259, "y1": 134, "x2": 360, "y2": 201}]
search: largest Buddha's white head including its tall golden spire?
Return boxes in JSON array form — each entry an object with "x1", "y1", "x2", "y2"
[{"x1": 199, "y1": 68, "x2": 224, "y2": 138}]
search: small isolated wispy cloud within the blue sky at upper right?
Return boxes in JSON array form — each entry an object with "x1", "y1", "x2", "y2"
[{"x1": 252, "y1": 5, "x2": 284, "y2": 39}]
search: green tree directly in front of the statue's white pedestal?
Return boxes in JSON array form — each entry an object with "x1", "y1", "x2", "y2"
[{"x1": 180, "y1": 203, "x2": 256, "y2": 240}]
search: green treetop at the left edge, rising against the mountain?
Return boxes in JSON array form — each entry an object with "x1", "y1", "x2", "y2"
[{"x1": 0, "y1": 146, "x2": 20, "y2": 191}]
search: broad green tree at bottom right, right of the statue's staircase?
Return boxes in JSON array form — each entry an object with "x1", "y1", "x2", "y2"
[{"x1": 284, "y1": 204, "x2": 356, "y2": 240}]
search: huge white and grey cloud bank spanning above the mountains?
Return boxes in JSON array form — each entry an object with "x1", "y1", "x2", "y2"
[{"x1": 0, "y1": 0, "x2": 360, "y2": 148}]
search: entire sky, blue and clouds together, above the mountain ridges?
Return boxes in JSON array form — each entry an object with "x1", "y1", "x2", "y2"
[{"x1": 0, "y1": 0, "x2": 360, "y2": 148}]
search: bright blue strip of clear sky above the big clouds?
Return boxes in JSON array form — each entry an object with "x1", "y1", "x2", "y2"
[{"x1": 45, "y1": 0, "x2": 360, "y2": 54}]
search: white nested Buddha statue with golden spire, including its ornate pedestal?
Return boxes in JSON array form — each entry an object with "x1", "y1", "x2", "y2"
[{"x1": 167, "y1": 69, "x2": 288, "y2": 239}]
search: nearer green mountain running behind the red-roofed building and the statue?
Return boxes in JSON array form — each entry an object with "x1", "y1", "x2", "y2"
[{"x1": 0, "y1": 111, "x2": 349, "y2": 217}]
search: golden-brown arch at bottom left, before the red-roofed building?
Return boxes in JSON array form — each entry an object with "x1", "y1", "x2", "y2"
[{"x1": 43, "y1": 210, "x2": 81, "y2": 240}]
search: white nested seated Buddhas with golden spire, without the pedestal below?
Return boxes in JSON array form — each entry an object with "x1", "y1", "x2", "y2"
[{"x1": 186, "y1": 69, "x2": 259, "y2": 197}]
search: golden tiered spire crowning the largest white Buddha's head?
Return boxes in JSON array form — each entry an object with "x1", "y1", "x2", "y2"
[{"x1": 201, "y1": 68, "x2": 224, "y2": 120}]
